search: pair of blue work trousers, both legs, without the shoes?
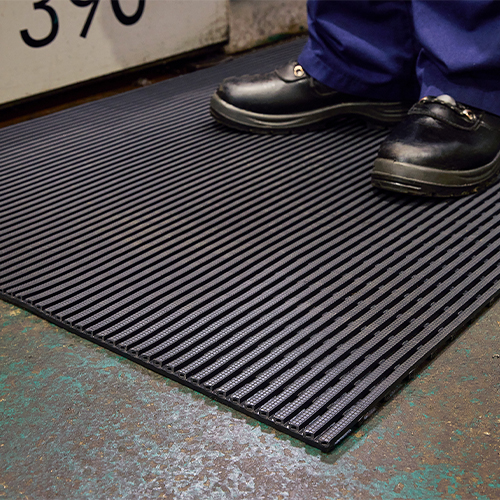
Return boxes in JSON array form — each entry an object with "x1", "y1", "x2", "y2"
[{"x1": 299, "y1": 0, "x2": 500, "y2": 115}]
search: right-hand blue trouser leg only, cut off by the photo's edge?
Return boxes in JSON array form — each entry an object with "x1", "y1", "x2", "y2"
[{"x1": 413, "y1": 0, "x2": 500, "y2": 115}]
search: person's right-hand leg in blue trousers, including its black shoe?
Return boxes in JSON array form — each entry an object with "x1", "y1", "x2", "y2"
[{"x1": 372, "y1": 1, "x2": 500, "y2": 196}]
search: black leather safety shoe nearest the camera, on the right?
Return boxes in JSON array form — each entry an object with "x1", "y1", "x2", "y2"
[{"x1": 372, "y1": 95, "x2": 500, "y2": 196}]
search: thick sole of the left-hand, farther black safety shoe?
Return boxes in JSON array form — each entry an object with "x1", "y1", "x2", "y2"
[{"x1": 210, "y1": 94, "x2": 409, "y2": 134}]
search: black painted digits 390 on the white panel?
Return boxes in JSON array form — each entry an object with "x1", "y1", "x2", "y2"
[{"x1": 21, "y1": 0, "x2": 146, "y2": 47}]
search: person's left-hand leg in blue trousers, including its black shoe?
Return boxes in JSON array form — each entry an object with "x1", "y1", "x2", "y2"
[{"x1": 210, "y1": 0, "x2": 418, "y2": 133}]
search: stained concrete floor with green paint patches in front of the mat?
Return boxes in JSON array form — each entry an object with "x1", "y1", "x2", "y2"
[{"x1": 0, "y1": 301, "x2": 500, "y2": 500}]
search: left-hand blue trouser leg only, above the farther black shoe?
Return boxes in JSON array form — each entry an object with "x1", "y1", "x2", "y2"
[{"x1": 298, "y1": 0, "x2": 419, "y2": 102}]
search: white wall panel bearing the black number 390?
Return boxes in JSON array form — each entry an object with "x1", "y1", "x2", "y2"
[{"x1": 0, "y1": 0, "x2": 227, "y2": 103}]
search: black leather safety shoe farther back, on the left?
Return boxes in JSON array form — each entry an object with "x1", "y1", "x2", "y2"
[{"x1": 210, "y1": 62, "x2": 410, "y2": 133}]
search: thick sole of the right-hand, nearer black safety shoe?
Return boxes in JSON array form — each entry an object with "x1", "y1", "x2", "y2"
[{"x1": 372, "y1": 152, "x2": 500, "y2": 197}]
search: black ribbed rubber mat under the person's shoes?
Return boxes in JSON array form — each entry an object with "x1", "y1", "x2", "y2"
[{"x1": 0, "y1": 41, "x2": 500, "y2": 450}]
